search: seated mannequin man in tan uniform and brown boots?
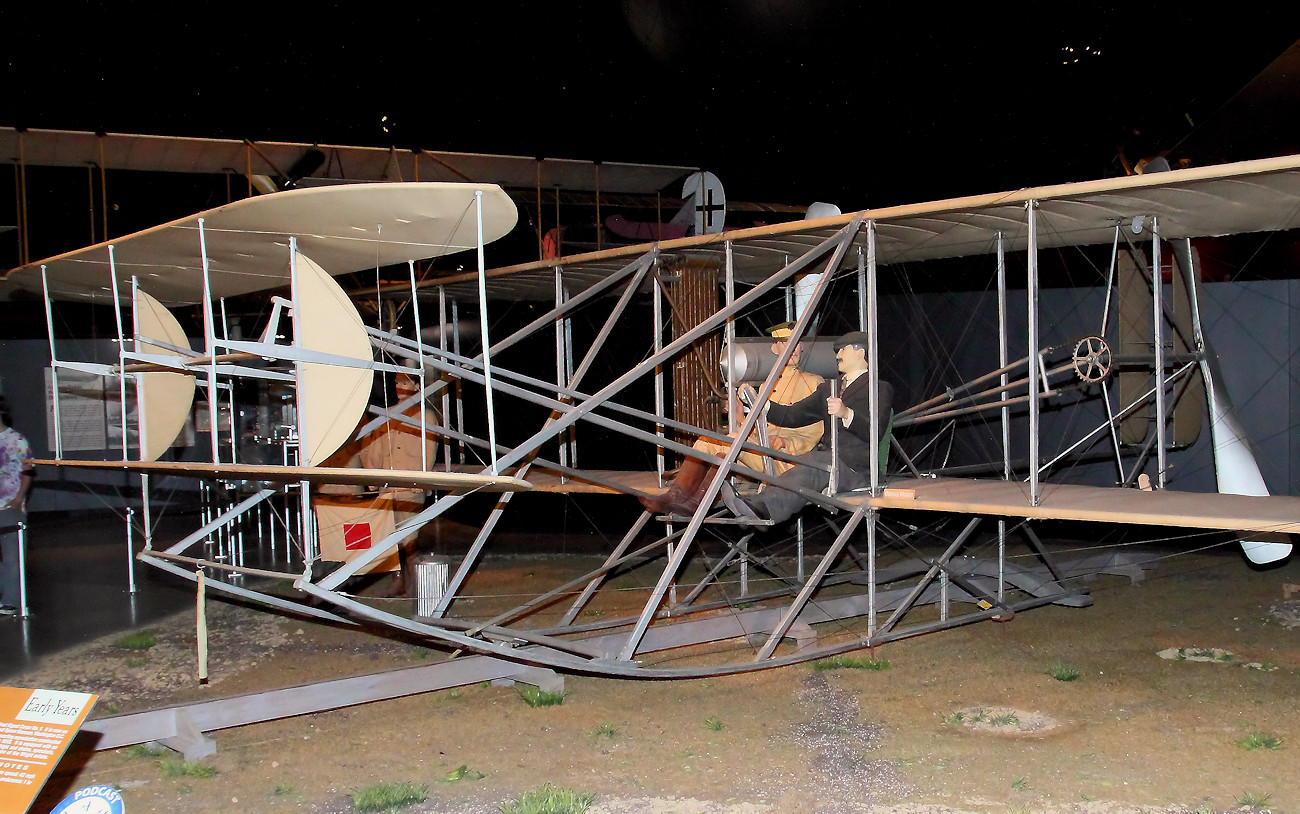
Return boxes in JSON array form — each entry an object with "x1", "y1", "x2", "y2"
[{"x1": 640, "y1": 322, "x2": 824, "y2": 515}]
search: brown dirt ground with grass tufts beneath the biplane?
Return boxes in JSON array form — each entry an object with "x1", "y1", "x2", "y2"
[{"x1": 10, "y1": 551, "x2": 1300, "y2": 814}]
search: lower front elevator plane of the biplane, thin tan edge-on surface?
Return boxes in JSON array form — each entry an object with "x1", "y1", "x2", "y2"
[{"x1": 30, "y1": 459, "x2": 532, "y2": 493}]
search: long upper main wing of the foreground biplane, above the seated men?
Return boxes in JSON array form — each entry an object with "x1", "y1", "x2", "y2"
[{"x1": 424, "y1": 150, "x2": 1300, "y2": 299}]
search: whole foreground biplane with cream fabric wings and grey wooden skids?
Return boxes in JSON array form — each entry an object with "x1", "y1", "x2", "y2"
[{"x1": 8, "y1": 156, "x2": 1300, "y2": 677}]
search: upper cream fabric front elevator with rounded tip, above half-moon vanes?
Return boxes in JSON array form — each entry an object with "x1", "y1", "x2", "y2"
[{"x1": 5, "y1": 183, "x2": 517, "y2": 304}]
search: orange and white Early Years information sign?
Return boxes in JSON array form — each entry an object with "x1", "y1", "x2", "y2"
[{"x1": 0, "y1": 687, "x2": 99, "y2": 811}]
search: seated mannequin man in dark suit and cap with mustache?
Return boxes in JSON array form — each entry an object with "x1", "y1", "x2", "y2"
[{"x1": 723, "y1": 330, "x2": 893, "y2": 523}]
